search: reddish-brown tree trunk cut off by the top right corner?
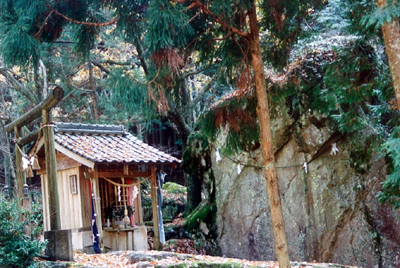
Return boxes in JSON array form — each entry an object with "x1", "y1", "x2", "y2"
[{"x1": 376, "y1": 0, "x2": 400, "y2": 111}]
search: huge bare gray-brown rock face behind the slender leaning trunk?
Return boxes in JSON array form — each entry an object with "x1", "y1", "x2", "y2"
[{"x1": 212, "y1": 102, "x2": 400, "y2": 267}]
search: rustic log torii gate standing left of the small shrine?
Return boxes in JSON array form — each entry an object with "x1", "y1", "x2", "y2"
[{"x1": 4, "y1": 87, "x2": 72, "y2": 261}]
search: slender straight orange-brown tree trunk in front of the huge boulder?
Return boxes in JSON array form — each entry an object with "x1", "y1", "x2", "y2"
[{"x1": 249, "y1": 2, "x2": 290, "y2": 268}]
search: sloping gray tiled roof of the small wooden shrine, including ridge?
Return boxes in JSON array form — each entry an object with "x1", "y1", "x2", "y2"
[{"x1": 54, "y1": 123, "x2": 181, "y2": 164}]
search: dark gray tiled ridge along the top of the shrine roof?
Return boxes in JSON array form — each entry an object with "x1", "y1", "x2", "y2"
[{"x1": 55, "y1": 122, "x2": 129, "y2": 136}]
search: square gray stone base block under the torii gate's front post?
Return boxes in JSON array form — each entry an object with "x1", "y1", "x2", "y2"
[{"x1": 44, "y1": 229, "x2": 73, "y2": 261}]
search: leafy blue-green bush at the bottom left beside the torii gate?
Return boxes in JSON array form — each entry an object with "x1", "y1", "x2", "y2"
[{"x1": 0, "y1": 195, "x2": 45, "y2": 268}]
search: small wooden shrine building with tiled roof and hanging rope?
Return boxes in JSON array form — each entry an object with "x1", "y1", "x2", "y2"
[{"x1": 31, "y1": 123, "x2": 180, "y2": 250}]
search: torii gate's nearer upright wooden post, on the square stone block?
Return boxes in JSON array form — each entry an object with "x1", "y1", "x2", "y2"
[{"x1": 42, "y1": 109, "x2": 61, "y2": 231}]
